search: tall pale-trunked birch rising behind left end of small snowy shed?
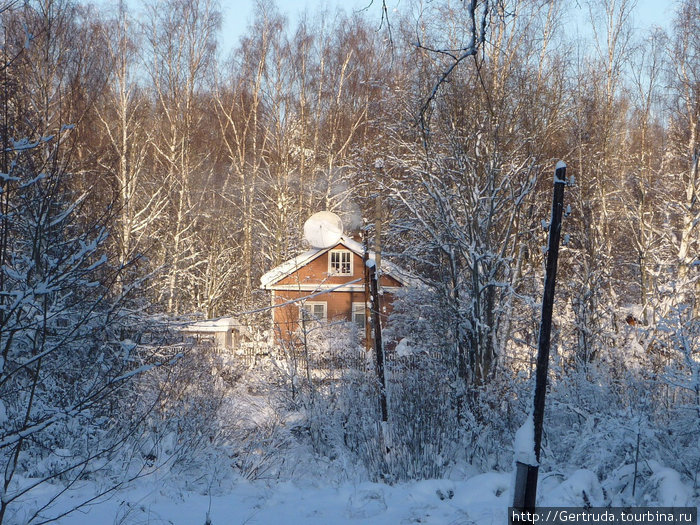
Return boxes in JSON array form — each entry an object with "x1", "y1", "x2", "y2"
[{"x1": 145, "y1": 0, "x2": 221, "y2": 313}]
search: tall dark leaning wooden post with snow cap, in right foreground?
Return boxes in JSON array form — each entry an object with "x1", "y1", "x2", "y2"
[{"x1": 513, "y1": 161, "x2": 566, "y2": 509}]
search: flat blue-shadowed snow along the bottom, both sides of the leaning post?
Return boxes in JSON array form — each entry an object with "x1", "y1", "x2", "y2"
[{"x1": 14, "y1": 465, "x2": 700, "y2": 525}]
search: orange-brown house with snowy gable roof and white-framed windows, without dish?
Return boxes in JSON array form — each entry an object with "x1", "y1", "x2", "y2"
[{"x1": 260, "y1": 235, "x2": 408, "y2": 343}]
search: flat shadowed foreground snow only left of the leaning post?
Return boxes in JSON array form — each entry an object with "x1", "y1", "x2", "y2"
[{"x1": 18, "y1": 473, "x2": 512, "y2": 525}]
